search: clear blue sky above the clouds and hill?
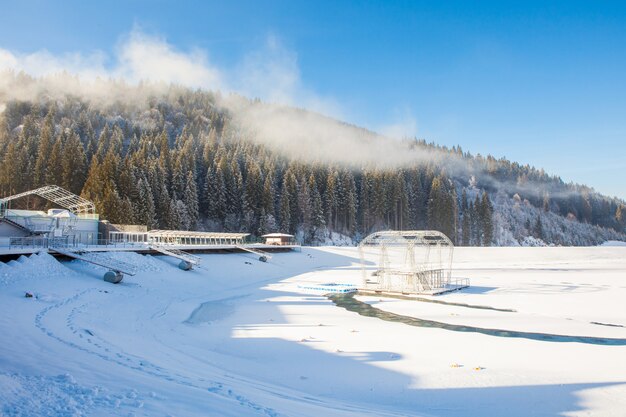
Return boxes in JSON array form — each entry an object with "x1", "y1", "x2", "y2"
[{"x1": 0, "y1": 0, "x2": 626, "y2": 198}]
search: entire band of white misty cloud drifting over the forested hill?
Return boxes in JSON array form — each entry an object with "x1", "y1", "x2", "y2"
[{"x1": 0, "y1": 28, "x2": 433, "y2": 166}]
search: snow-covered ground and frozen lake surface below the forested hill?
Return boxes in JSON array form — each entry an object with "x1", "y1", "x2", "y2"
[{"x1": 0, "y1": 247, "x2": 626, "y2": 417}]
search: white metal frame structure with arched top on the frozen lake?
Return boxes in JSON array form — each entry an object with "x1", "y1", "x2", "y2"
[{"x1": 359, "y1": 230, "x2": 466, "y2": 294}]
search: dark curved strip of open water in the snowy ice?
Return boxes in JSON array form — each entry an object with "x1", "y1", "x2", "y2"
[{"x1": 327, "y1": 294, "x2": 626, "y2": 346}]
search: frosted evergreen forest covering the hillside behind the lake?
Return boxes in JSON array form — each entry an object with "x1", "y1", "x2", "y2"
[{"x1": 0, "y1": 75, "x2": 626, "y2": 245}]
